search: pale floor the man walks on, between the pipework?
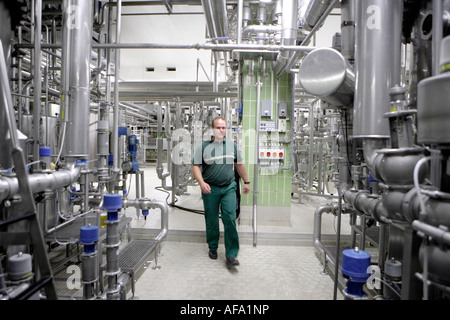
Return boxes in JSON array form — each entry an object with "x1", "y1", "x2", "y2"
[{"x1": 121, "y1": 165, "x2": 349, "y2": 300}]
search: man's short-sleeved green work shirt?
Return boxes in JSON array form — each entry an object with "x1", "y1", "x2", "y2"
[{"x1": 192, "y1": 139, "x2": 242, "y2": 187}]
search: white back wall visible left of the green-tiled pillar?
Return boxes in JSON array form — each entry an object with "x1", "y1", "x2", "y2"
[{"x1": 120, "y1": 5, "x2": 211, "y2": 81}]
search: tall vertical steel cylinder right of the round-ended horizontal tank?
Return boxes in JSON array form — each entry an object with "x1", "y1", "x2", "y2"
[{"x1": 353, "y1": 0, "x2": 403, "y2": 139}]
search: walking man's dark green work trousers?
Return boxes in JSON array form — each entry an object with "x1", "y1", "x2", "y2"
[{"x1": 202, "y1": 181, "x2": 239, "y2": 258}]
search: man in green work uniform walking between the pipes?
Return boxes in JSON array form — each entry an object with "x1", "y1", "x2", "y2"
[{"x1": 192, "y1": 117, "x2": 250, "y2": 266}]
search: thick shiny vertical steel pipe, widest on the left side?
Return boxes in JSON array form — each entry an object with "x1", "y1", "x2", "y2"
[{"x1": 61, "y1": 0, "x2": 93, "y2": 159}]
